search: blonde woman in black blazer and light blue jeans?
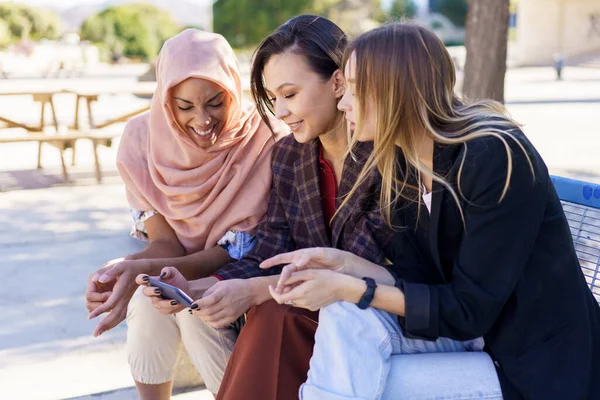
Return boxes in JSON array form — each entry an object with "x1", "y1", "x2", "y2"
[{"x1": 262, "y1": 23, "x2": 600, "y2": 400}]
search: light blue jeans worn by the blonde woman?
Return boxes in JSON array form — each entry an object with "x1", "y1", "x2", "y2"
[{"x1": 299, "y1": 302, "x2": 502, "y2": 400}]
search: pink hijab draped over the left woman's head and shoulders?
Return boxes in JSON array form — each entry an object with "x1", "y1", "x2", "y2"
[{"x1": 117, "y1": 29, "x2": 274, "y2": 253}]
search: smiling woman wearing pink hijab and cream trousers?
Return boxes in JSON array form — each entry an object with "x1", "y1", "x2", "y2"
[{"x1": 87, "y1": 29, "x2": 282, "y2": 399}]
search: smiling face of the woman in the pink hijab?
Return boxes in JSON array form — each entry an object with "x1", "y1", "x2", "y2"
[{"x1": 170, "y1": 78, "x2": 231, "y2": 148}]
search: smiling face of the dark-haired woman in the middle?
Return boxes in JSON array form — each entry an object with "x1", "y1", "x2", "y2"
[{"x1": 263, "y1": 52, "x2": 342, "y2": 143}]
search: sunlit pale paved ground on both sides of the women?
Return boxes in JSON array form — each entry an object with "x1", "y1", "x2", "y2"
[{"x1": 0, "y1": 61, "x2": 600, "y2": 400}]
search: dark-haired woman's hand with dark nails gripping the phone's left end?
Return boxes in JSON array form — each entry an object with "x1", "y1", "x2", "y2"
[{"x1": 135, "y1": 267, "x2": 190, "y2": 315}]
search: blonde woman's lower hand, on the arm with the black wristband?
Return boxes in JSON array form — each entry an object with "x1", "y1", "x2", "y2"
[{"x1": 269, "y1": 266, "x2": 365, "y2": 311}]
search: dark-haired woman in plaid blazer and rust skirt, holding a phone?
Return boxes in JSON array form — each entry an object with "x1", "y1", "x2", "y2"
[{"x1": 138, "y1": 15, "x2": 390, "y2": 400}]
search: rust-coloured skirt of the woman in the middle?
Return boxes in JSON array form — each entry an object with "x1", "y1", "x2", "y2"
[{"x1": 217, "y1": 300, "x2": 319, "y2": 400}]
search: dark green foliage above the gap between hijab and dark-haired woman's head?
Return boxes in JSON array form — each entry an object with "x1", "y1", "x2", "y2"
[{"x1": 213, "y1": 0, "x2": 314, "y2": 48}]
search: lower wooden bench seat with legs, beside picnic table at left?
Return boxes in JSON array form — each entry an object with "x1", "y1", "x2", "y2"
[{"x1": 0, "y1": 131, "x2": 121, "y2": 183}]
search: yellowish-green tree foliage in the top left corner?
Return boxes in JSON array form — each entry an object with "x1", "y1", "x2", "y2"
[{"x1": 0, "y1": 3, "x2": 61, "y2": 45}]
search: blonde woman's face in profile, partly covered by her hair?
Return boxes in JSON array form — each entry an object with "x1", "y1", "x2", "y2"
[{"x1": 338, "y1": 53, "x2": 377, "y2": 142}]
